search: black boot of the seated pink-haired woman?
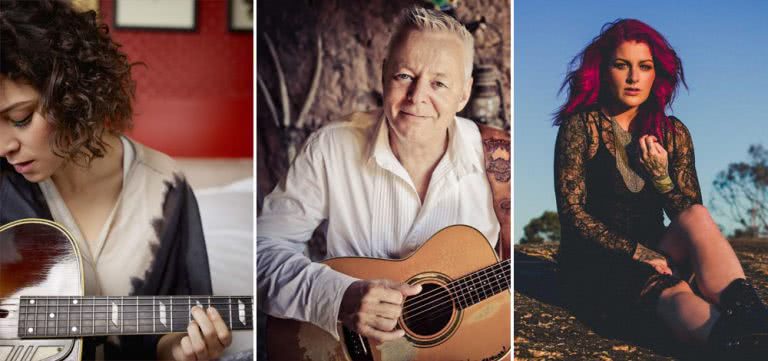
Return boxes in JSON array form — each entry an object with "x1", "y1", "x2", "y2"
[{"x1": 709, "y1": 279, "x2": 768, "y2": 361}]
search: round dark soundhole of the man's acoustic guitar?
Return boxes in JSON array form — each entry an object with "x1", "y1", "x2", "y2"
[{"x1": 402, "y1": 283, "x2": 454, "y2": 336}]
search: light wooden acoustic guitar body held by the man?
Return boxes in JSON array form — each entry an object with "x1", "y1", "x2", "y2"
[{"x1": 267, "y1": 226, "x2": 511, "y2": 361}]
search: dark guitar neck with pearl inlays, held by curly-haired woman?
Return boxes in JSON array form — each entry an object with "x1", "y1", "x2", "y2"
[{"x1": 18, "y1": 296, "x2": 253, "y2": 338}]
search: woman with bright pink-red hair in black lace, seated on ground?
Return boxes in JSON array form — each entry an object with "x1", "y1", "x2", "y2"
[{"x1": 554, "y1": 19, "x2": 768, "y2": 358}]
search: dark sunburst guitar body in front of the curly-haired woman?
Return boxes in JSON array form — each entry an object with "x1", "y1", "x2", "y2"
[{"x1": 0, "y1": 219, "x2": 84, "y2": 361}]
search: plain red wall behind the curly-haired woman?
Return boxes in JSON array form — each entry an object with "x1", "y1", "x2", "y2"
[{"x1": 99, "y1": 0, "x2": 253, "y2": 157}]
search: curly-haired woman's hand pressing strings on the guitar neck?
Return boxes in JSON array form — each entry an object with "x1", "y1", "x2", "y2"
[{"x1": 157, "y1": 306, "x2": 232, "y2": 361}]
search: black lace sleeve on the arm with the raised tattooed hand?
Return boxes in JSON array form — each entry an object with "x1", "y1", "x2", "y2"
[{"x1": 662, "y1": 117, "x2": 702, "y2": 219}]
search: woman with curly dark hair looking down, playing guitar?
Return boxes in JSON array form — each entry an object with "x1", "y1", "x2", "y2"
[{"x1": 0, "y1": 0, "x2": 231, "y2": 360}]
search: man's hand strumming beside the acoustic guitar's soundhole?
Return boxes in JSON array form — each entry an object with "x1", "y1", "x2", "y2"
[{"x1": 339, "y1": 280, "x2": 421, "y2": 342}]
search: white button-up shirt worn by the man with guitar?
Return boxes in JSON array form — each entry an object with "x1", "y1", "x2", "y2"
[{"x1": 256, "y1": 110, "x2": 500, "y2": 339}]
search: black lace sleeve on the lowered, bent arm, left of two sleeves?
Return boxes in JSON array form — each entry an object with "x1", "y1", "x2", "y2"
[{"x1": 555, "y1": 117, "x2": 637, "y2": 257}]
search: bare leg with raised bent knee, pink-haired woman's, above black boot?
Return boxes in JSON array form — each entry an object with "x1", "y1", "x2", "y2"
[{"x1": 659, "y1": 204, "x2": 745, "y2": 304}]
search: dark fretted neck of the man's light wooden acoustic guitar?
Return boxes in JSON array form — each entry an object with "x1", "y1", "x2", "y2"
[{"x1": 448, "y1": 259, "x2": 512, "y2": 309}]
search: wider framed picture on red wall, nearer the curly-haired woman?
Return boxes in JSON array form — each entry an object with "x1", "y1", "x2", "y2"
[{"x1": 114, "y1": 0, "x2": 197, "y2": 31}]
